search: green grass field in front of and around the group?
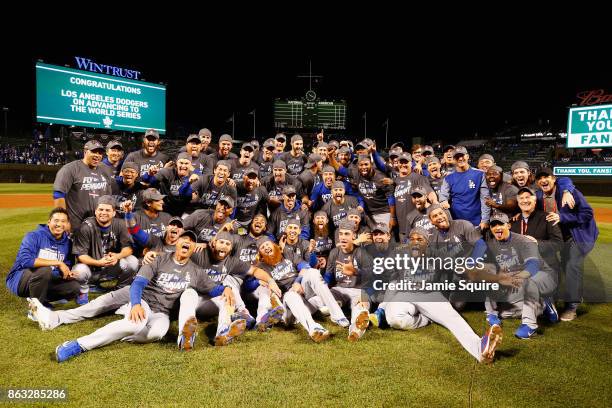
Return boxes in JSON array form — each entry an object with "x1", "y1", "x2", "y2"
[{"x1": 0, "y1": 185, "x2": 612, "y2": 407}]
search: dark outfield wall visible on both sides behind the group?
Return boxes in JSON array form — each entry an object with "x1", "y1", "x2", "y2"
[{"x1": 0, "y1": 164, "x2": 612, "y2": 197}]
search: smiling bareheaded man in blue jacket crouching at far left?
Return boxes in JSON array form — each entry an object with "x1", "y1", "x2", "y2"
[{"x1": 6, "y1": 207, "x2": 80, "y2": 302}]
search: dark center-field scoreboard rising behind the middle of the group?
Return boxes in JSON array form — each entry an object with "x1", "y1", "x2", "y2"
[{"x1": 274, "y1": 97, "x2": 346, "y2": 130}]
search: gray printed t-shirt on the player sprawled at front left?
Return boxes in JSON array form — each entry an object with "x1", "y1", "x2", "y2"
[{"x1": 138, "y1": 252, "x2": 217, "y2": 314}]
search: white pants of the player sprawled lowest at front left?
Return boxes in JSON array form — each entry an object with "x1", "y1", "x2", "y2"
[{"x1": 77, "y1": 300, "x2": 170, "y2": 350}]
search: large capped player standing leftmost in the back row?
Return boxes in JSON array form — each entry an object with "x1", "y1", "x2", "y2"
[{"x1": 53, "y1": 140, "x2": 112, "y2": 231}]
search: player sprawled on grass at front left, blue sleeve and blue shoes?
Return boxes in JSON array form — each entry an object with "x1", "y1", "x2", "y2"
[{"x1": 48, "y1": 231, "x2": 234, "y2": 363}]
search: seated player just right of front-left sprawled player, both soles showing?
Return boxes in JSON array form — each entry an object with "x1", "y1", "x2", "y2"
[{"x1": 178, "y1": 231, "x2": 282, "y2": 350}]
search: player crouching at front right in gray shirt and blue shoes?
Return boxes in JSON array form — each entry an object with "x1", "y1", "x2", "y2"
[{"x1": 485, "y1": 213, "x2": 559, "y2": 339}]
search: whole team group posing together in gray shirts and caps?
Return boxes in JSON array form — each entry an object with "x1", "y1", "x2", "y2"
[{"x1": 7, "y1": 129, "x2": 598, "y2": 362}]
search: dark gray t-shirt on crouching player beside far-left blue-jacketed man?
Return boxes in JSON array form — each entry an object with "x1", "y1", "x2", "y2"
[{"x1": 72, "y1": 217, "x2": 132, "y2": 268}]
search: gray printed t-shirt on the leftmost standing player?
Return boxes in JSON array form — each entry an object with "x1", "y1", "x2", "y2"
[{"x1": 53, "y1": 160, "x2": 112, "y2": 231}]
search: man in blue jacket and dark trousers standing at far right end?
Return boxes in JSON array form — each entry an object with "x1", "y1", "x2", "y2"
[{"x1": 536, "y1": 168, "x2": 599, "y2": 321}]
